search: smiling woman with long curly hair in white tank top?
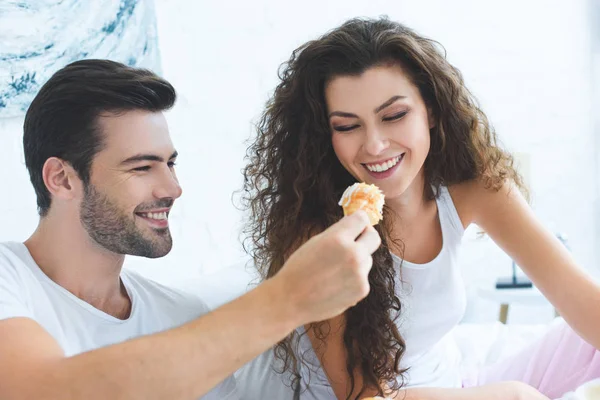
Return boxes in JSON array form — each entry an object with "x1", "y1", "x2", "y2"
[{"x1": 240, "y1": 19, "x2": 600, "y2": 399}]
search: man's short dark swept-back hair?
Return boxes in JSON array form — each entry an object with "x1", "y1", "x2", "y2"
[{"x1": 23, "y1": 60, "x2": 177, "y2": 217}]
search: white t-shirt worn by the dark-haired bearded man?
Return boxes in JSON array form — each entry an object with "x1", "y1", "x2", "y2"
[{"x1": 0, "y1": 242, "x2": 239, "y2": 400}]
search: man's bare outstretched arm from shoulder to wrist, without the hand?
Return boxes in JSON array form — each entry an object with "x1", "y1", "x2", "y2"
[{"x1": 0, "y1": 282, "x2": 297, "y2": 400}]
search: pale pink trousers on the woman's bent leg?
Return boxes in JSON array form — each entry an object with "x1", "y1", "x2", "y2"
[{"x1": 463, "y1": 321, "x2": 600, "y2": 399}]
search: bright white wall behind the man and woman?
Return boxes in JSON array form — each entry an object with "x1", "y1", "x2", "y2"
[{"x1": 0, "y1": 0, "x2": 598, "y2": 306}]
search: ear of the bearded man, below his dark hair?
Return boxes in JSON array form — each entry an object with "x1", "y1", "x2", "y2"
[{"x1": 42, "y1": 157, "x2": 82, "y2": 201}]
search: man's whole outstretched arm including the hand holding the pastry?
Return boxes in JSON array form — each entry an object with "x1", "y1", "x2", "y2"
[{"x1": 0, "y1": 212, "x2": 380, "y2": 400}]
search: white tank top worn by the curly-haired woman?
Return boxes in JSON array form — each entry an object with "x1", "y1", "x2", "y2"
[{"x1": 299, "y1": 187, "x2": 467, "y2": 400}]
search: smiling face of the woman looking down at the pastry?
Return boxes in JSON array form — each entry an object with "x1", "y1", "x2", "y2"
[{"x1": 325, "y1": 65, "x2": 432, "y2": 199}]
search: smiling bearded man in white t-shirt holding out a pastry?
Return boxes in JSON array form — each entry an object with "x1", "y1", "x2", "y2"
[{"x1": 0, "y1": 60, "x2": 380, "y2": 400}]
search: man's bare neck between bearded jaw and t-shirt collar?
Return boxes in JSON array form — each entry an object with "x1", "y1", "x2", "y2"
[{"x1": 25, "y1": 215, "x2": 131, "y2": 318}]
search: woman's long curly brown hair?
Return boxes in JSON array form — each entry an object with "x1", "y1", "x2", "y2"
[{"x1": 244, "y1": 18, "x2": 522, "y2": 398}]
